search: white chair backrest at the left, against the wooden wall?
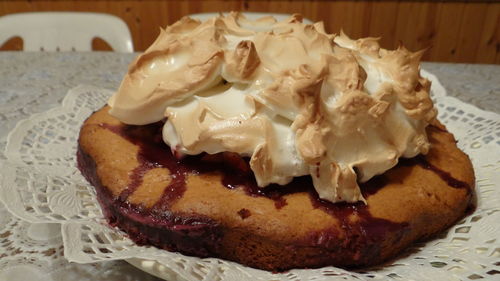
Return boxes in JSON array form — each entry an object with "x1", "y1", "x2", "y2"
[{"x1": 0, "y1": 12, "x2": 134, "y2": 52}]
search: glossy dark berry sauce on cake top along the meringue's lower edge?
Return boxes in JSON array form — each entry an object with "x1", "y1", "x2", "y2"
[{"x1": 101, "y1": 122, "x2": 470, "y2": 212}]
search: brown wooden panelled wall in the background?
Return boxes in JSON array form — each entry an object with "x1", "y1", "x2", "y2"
[{"x1": 0, "y1": 0, "x2": 500, "y2": 64}]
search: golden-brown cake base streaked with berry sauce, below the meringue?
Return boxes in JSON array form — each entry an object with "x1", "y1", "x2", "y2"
[{"x1": 78, "y1": 107, "x2": 474, "y2": 271}]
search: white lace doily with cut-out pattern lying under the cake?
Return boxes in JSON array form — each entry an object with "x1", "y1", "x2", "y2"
[{"x1": 0, "y1": 77, "x2": 500, "y2": 281}]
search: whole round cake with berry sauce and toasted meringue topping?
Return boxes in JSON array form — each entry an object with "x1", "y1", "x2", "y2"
[{"x1": 77, "y1": 13, "x2": 474, "y2": 271}]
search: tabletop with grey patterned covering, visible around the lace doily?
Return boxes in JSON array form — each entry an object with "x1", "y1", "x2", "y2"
[{"x1": 0, "y1": 52, "x2": 500, "y2": 280}]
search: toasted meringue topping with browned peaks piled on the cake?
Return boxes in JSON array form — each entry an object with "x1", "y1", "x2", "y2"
[{"x1": 109, "y1": 13, "x2": 436, "y2": 202}]
